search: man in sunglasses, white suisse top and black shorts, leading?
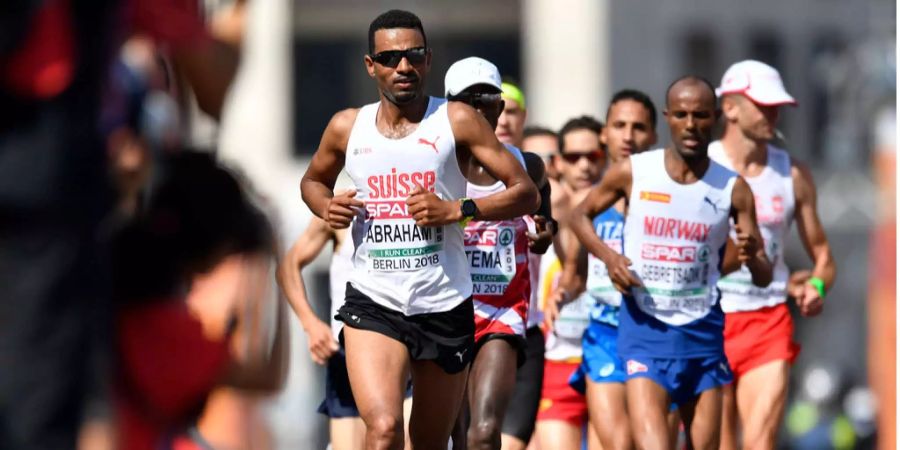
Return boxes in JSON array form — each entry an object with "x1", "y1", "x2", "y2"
[{"x1": 301, "y1": 10, "x2": 540, "y2": 449}]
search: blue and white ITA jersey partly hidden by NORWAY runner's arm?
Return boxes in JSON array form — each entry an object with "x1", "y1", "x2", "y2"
[{"x1": 586, "y1": 207, "x2": 625, "y2": 326}]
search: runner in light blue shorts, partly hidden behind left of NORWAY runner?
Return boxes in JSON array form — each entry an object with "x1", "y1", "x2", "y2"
[{"x1": 564, "y1": 89, "x2": 656, "y2": 450}]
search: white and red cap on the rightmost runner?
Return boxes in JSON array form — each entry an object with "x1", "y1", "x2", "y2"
[{"x1": 716, "y1": 59, "x2": 797, "y2": 106}]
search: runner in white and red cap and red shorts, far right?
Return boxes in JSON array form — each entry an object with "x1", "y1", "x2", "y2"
[{"x1": 709, "y1": 60, "x2": 835, "y2": 449}]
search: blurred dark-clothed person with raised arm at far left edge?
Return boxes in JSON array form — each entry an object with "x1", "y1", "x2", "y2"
[{"x1": 0, "y1": 0, "x2": 244, "y2": 449}]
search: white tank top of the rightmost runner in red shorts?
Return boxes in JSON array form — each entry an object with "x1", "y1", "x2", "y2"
[{"x1": 709, "y1": 141, "x2": 794, "y2": 313}]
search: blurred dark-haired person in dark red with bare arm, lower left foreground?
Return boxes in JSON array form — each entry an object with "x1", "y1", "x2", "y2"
[{"x1": 113, "y1": 153, "x2": 285, "y2": 449}]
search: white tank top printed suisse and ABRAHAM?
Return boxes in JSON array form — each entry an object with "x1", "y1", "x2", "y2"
[{"x1": 346, "y1": 97, "x2": 472, "y2": 316}]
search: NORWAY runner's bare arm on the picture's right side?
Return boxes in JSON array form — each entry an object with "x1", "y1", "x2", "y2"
[{"x1": 731, "y1": 177, "x2": 772, "y2": 287}]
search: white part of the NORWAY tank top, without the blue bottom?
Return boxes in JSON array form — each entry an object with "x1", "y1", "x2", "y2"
[{"x1": 624, "y1": 150, "x2": 737, "y2": 326}]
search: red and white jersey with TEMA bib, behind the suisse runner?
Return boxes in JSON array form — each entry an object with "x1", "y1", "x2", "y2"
[{"x1": 465, "y1": 145, "x2": 531, "y2": 336}]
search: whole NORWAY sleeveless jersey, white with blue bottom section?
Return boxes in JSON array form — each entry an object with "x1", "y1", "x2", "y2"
[{"x1": 619, "y1": 150, "x2": 737, "y2": 358}]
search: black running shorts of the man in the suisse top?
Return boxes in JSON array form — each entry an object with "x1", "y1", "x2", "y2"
[{"x1": 334, "y1": 283, "x2": 475, "y2": 374}]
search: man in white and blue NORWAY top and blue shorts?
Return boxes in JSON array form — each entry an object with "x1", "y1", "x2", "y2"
[{"x1": 572, "y1": 76, "x2": 772, "y2": 449}]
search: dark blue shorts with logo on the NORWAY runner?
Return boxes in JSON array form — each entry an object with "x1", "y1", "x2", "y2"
[{"x1": 622, "y1": 354, "x2": 734, "y2": 405}]
